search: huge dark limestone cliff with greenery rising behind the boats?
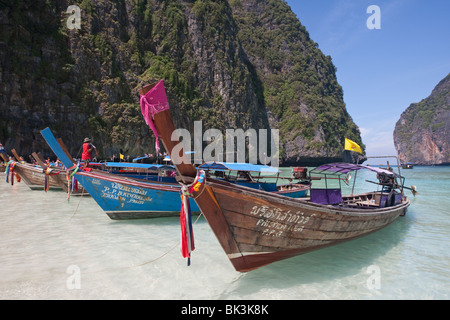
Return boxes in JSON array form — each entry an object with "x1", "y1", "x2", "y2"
[{"x1": 0, "y1": 0, "x2": 362, "y2": 164}]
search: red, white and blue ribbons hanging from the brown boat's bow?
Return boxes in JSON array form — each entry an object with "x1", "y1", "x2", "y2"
[{"x1": 180, "y1": 170, "x2": 206, "y2": 266}]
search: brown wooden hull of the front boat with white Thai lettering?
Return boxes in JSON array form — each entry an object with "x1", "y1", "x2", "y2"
[{"x1": 196, "y1": 181, "x2": 409, "y2": 272}]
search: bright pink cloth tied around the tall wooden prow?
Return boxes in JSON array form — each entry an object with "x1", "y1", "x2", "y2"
[{"x1": 141, "y1": 80, "x2": 169, "y2": 152}]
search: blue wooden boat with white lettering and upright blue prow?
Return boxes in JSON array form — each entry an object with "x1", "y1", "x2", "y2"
[{"x1": 41, "y1": 128, "x2": 200, "y2": 220}]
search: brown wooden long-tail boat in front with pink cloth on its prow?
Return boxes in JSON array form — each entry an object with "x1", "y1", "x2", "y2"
[{"x1": 139, "y1": 81, "x2": 410, "y2": 272}]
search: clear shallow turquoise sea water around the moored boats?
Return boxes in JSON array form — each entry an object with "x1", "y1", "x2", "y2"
[{"x1": 0, "y1": 167, "x2": 450, "y2": 300}]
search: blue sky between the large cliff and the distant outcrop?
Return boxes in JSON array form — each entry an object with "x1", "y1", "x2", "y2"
[{"x1": 286, "y1": 0, "x2": 450, "y2": 162}]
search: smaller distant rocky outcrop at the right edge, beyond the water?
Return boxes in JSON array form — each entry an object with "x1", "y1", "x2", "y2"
[{"x1": 394, "y1": 74, "x2": 450, "y2": 165}]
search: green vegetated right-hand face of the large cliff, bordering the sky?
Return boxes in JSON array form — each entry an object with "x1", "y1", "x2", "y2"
[{"x1": 230, "y1": 0, "x2": 363, "y2": 157}]
